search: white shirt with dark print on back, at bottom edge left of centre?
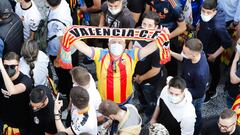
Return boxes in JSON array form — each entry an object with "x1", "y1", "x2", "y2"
[{"x1": 71, "y1": 104, "x2": 97, "y2": 135}]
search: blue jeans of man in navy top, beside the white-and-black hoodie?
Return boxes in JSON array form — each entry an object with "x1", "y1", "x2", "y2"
[{"x1": 192, "y1": 95, "x2": 205, "y2": 135}]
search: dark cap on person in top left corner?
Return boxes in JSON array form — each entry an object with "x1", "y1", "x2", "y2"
[{"x1": 0, "y1": 0, "x2": 13, "y2": 17}]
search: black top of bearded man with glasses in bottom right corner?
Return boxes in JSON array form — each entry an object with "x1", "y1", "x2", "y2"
[{"x1": 201, "y1": 118, "x2": 240, "y2": 135}]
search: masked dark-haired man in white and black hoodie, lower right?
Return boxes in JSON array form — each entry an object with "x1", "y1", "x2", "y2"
[{"x1": 150, "y1": 76, "x2": 196, "y2": 135}]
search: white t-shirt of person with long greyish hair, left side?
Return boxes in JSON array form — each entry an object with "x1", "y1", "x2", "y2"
[{"x1": 19, "y1": 51, "x2": 49, "y2": 86}]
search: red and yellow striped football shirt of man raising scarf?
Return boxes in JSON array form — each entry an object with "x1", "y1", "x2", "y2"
[{"x1": 92, "y1": 48, "x2": 139, "y2": 103}]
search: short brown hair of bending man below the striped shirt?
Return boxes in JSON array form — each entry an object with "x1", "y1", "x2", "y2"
[{"x1": 98, "y1": 100, "x2": 120, "y2": 116}]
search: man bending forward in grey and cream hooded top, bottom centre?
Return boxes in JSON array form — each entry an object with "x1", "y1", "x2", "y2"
[{"x1": 99, "y1": 100, "x2": 142, "y2": 135}]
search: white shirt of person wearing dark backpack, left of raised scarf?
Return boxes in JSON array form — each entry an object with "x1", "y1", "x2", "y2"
[{"x1": 47, "y1": 0, "x2": 72, "y2": 56}]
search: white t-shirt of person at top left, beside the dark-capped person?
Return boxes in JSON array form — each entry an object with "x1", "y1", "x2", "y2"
[{"x1": 15, "y1": 1, "x2": 41, "y2": 41}]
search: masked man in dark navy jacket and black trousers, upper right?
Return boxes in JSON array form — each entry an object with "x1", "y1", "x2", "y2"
[{"x1": 197, "y1": 0, "x2": 232, "y2": 102}]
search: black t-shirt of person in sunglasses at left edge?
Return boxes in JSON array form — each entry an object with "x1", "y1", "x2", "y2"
[{"x1": 0, "y1": 73, "x2": 32, "y2": 129}]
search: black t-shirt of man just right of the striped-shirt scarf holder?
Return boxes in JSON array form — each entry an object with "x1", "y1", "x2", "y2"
[{"x1": 134, "y1": 41, "x2": 163, "y2": 86}]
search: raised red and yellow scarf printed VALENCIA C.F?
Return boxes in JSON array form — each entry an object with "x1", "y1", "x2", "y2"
[{"x1": 54, "y1": 25, "x2": 171, "y2": 69}]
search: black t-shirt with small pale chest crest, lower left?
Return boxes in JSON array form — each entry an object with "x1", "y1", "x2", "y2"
[{"x1": 30, "y1": 86, "x2": 57, "y2": 135}]
